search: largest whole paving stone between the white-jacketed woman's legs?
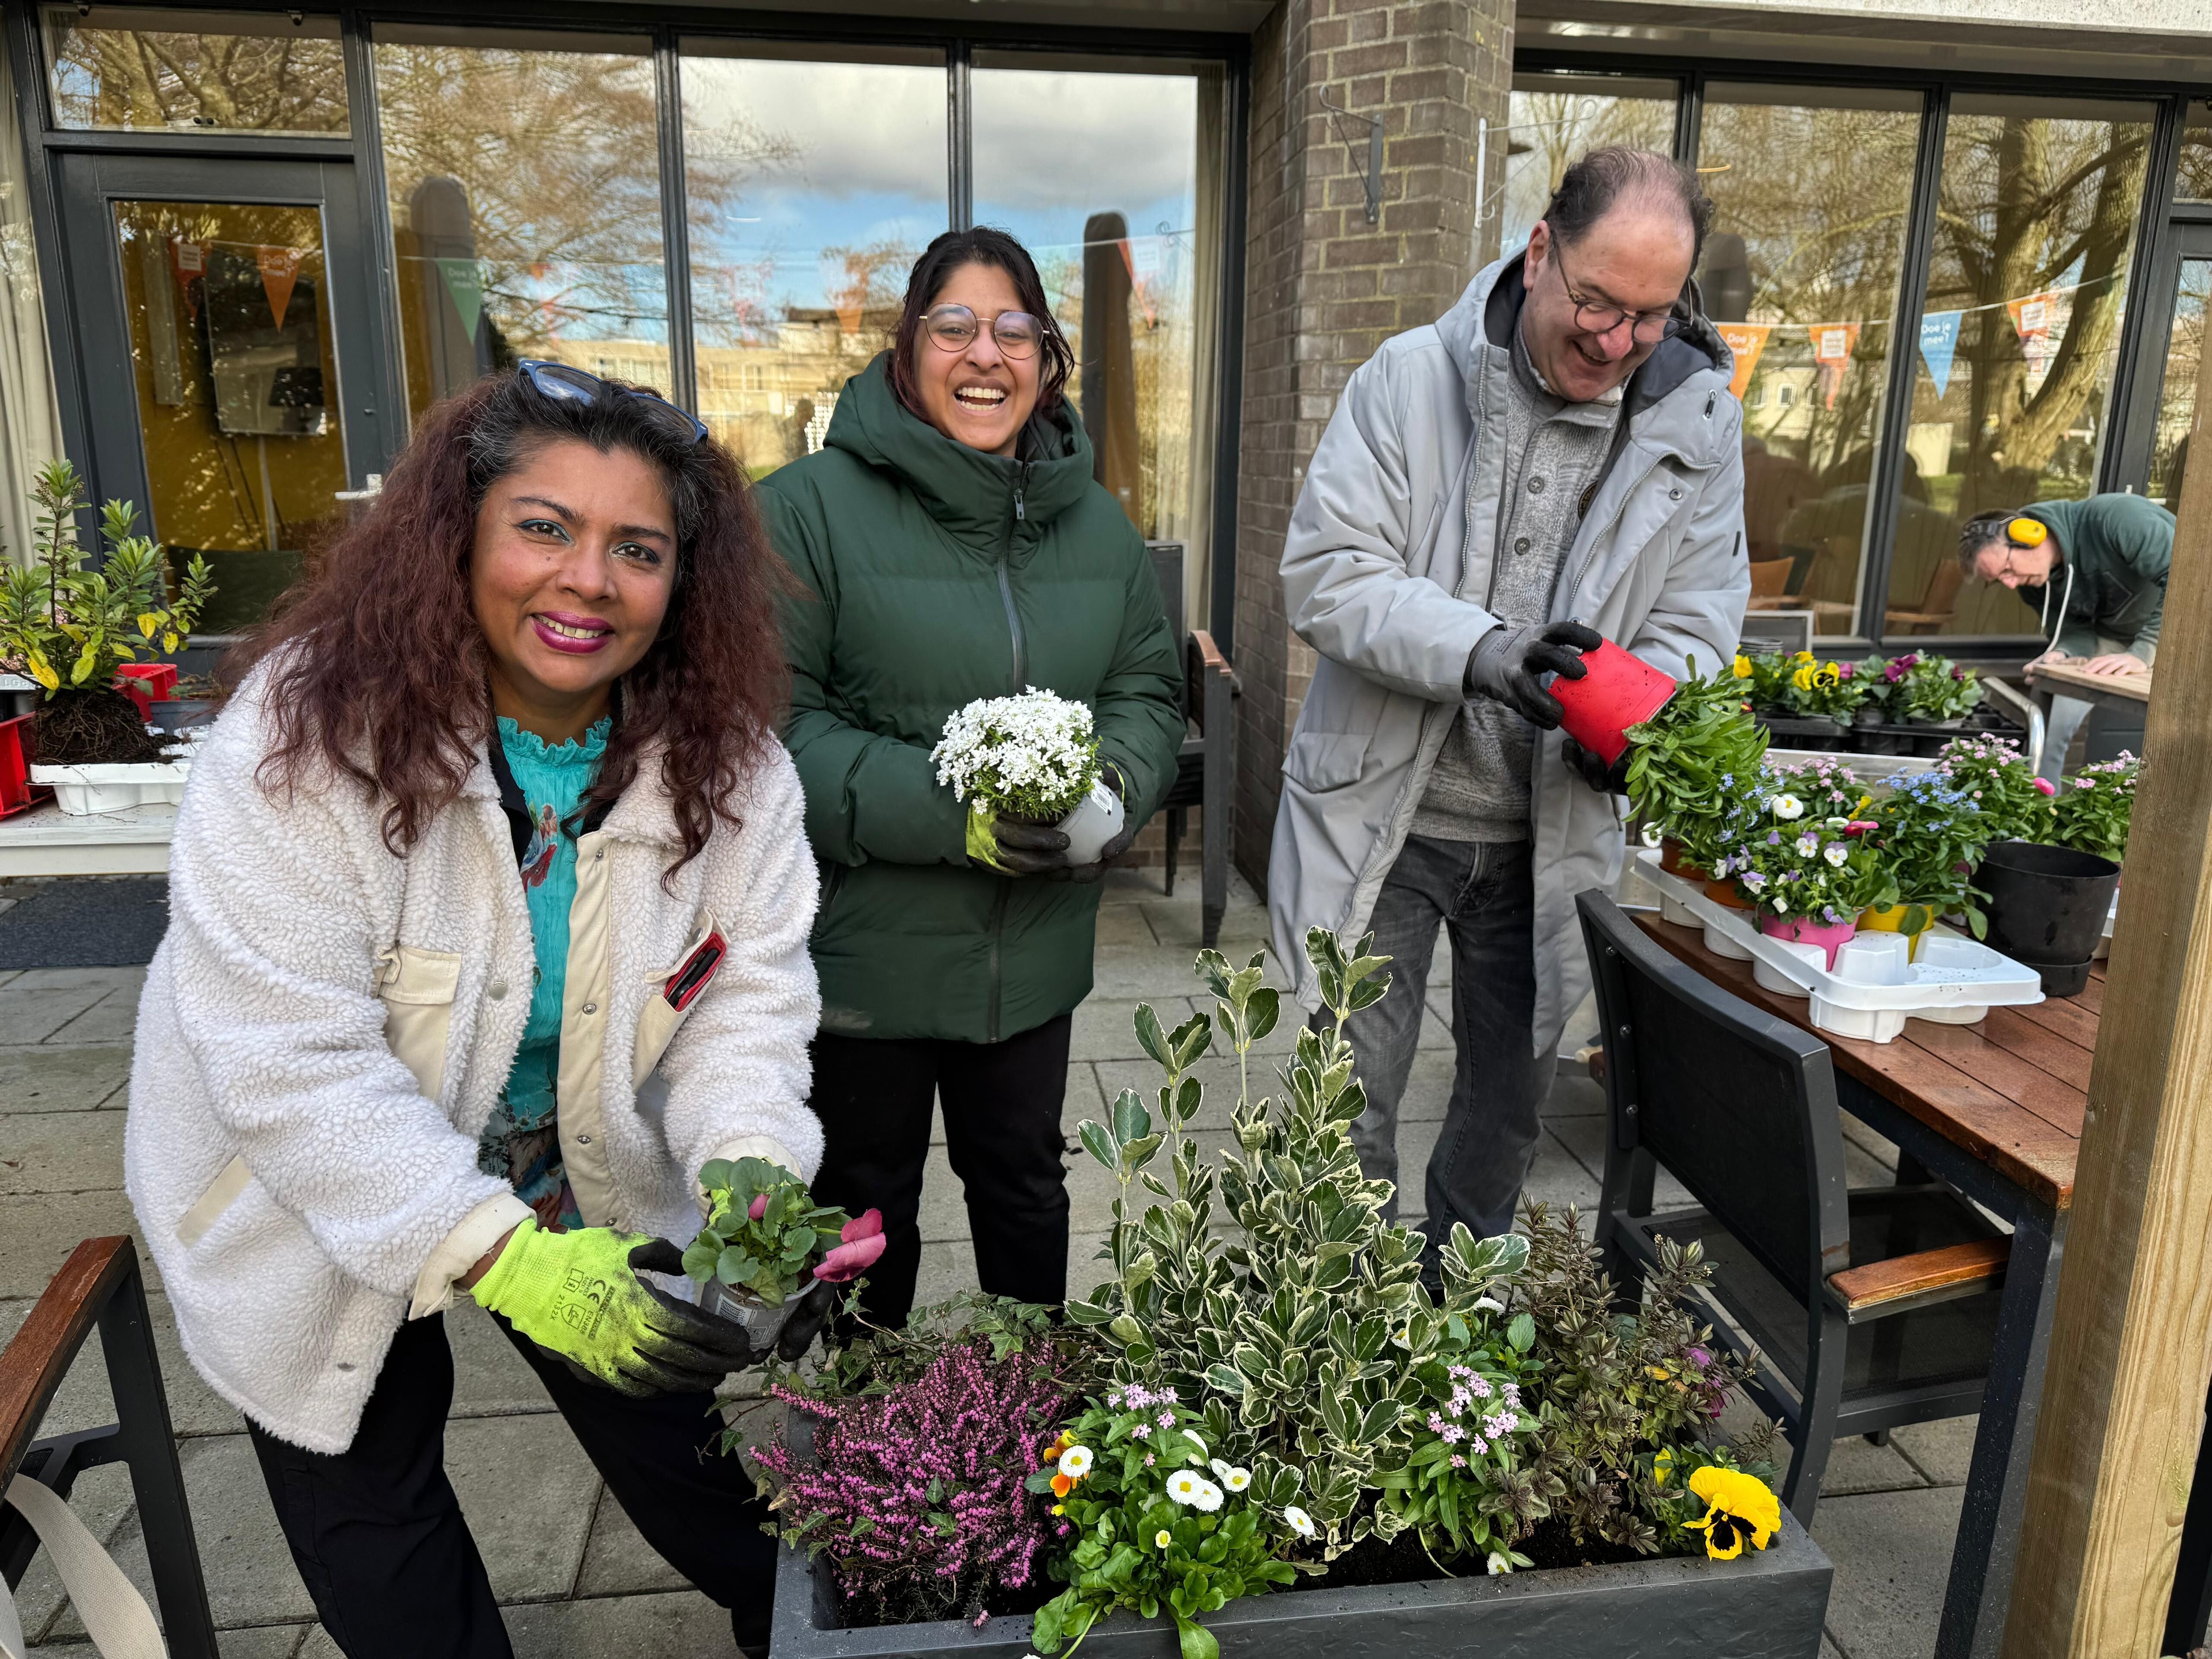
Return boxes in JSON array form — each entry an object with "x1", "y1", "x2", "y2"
[{"x1": 445, "y1": 1411, "x2": 600, "y2": 1602}]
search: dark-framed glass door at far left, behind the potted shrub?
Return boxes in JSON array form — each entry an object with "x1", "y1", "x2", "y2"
[{"x1": 62, "y1": 155, "x2": 385, "y2": 644}]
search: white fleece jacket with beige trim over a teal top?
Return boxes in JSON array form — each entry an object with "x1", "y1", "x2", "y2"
[{"x1": 124, "y1": 677, "x2": 821, "y2": 1453}]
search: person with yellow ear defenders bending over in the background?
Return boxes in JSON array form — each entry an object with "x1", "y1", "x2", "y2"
[{"x1": 1958, "y1": 493, "x2": 2174, "y2": 783}]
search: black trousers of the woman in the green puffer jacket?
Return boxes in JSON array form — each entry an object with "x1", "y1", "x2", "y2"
[{"x1": 814, "y1": 1013, "x2": 1075, "y2": 1327}]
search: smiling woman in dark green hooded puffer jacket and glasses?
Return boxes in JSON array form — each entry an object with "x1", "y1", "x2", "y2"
[{"x1": 759, "y1": 230, "x2": 1183, "y2": 1327}]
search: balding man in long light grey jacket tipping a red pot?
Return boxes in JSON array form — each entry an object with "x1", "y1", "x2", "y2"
[{"x1": 1268, "y1": 148, "x2": 1750, "y2": 1270}]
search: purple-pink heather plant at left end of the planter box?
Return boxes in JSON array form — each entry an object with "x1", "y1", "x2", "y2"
[{"x1": 754, "y1": 1341, "x2": 1073, "y2": 1624}]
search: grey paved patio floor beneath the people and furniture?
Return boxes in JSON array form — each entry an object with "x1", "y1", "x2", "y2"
[{"x1": 0, "y1": 869, "x2": 1973, "y2": 1659}]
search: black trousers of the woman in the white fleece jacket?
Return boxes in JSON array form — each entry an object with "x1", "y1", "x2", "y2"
[{"x1": 248, "y1": 1314, "x2": 776, "y2": 1659}]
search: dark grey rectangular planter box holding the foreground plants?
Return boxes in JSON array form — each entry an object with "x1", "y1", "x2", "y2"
[{"x1": 770, "y1": 1511, "x2": 1834, "y2": 1659}]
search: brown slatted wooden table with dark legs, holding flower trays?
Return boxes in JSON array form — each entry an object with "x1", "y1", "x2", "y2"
[{"x1": 1637, "y1": 911, "x2": 2104, "y2": 1659}]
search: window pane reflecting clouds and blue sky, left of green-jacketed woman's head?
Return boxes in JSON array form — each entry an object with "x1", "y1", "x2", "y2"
[{"x1": 683, "y1": 40, "x2": 949, "y2": 478}]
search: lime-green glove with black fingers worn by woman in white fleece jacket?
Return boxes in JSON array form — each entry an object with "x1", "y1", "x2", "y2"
[{"x1": 469, "y1": 1219, "x2": 754, "y2": 1396}]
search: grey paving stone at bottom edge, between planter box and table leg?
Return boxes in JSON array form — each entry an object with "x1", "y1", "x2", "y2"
[{"x1": 1812, "y1": 1487, "x2": 1964, "y2": 1659}]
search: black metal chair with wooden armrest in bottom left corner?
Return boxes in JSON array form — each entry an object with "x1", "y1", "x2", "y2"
[{"x1": 0, "y1": 1239, "x2": 217, "y2": 1659}]
